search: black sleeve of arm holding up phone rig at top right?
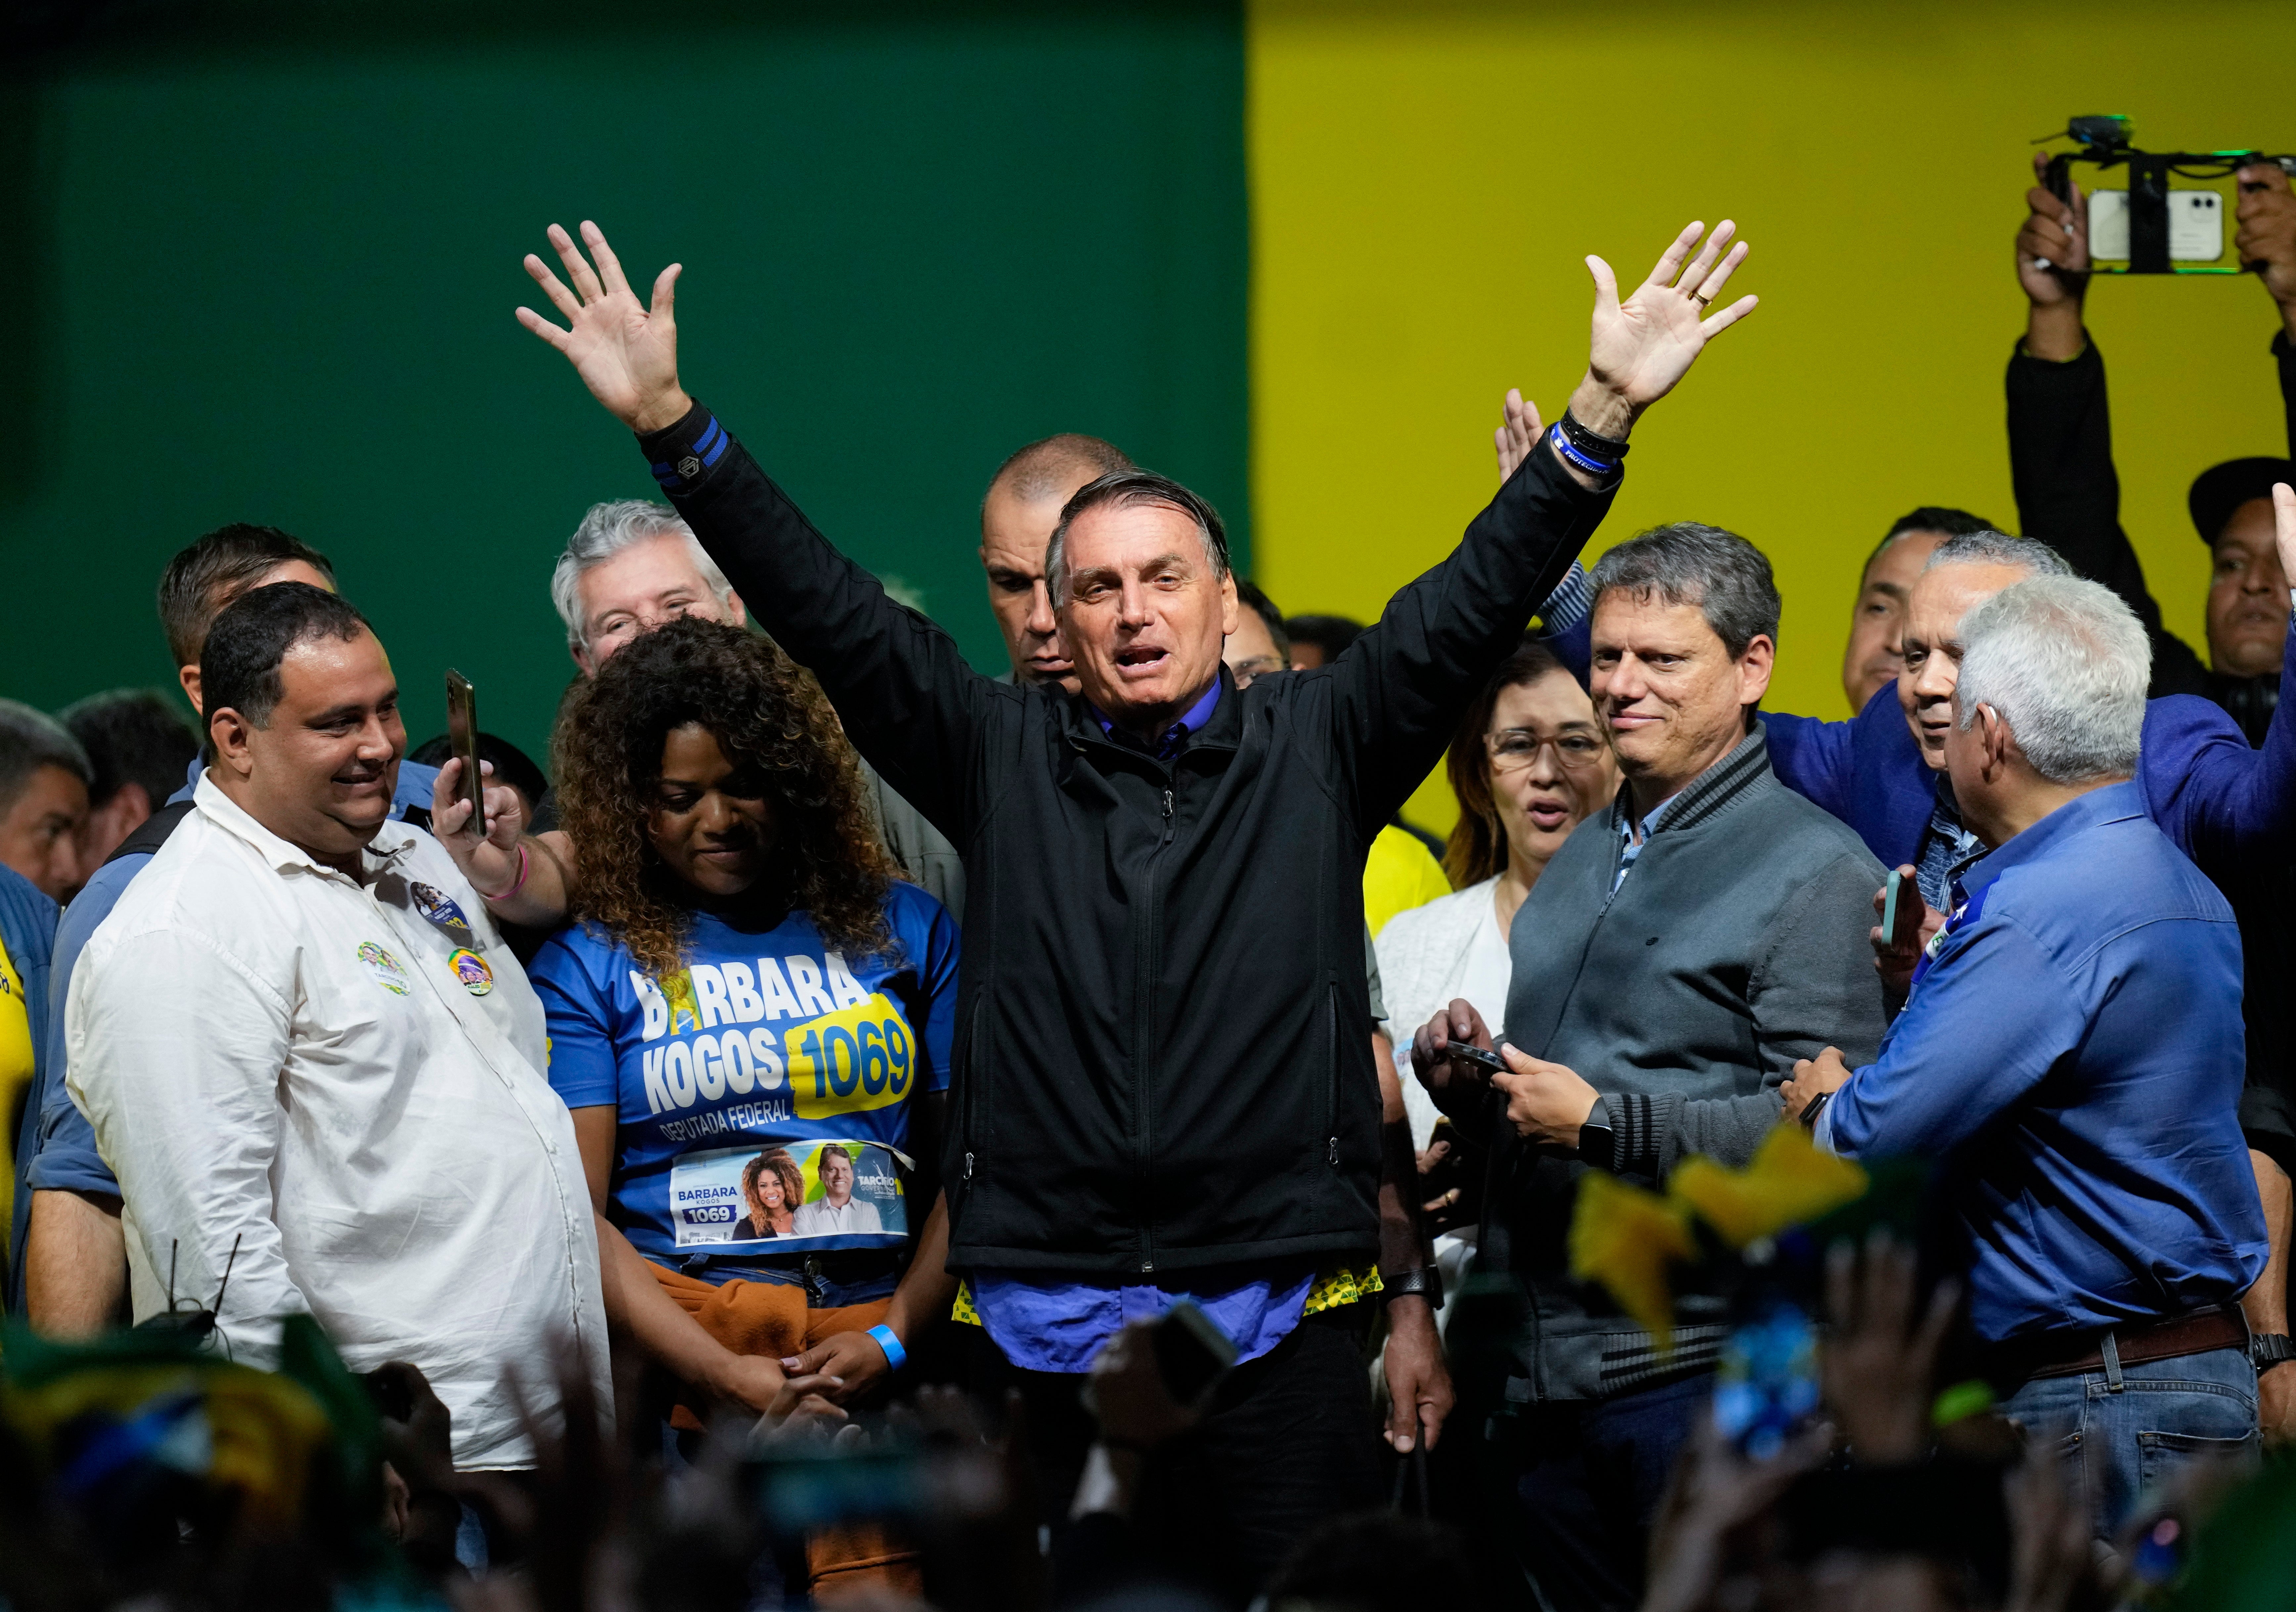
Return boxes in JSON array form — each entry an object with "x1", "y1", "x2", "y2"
[{"x1": 2009, "y1": 340, "x2": 2213, "y2": 696}]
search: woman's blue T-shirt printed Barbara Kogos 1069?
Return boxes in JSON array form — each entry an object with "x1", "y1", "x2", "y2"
[{"x1": 528, "y1": 882, "x2": 957, "y2": 1270}]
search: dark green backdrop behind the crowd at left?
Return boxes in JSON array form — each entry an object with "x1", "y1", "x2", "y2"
[{"x1": 0, "y1": 2, "x2": 1249, "y2": 760}]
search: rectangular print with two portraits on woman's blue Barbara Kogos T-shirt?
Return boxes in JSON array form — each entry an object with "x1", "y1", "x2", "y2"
[{"x1": 670, "y1": 1141, "x2": 909, "y2": 1252}]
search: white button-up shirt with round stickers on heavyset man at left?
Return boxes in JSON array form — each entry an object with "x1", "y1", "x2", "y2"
[{"x1": 64, "y1": 776, "x2": 613, "y2": 1470}]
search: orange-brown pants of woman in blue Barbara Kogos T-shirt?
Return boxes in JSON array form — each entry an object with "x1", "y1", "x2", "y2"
[{"x1": 650, "y1": 1265, "x2": 925, "y2": 1603}]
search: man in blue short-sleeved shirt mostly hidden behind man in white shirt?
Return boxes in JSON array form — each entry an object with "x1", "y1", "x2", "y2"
[{"x1": 7, "y1": 524, "x2": 546, "y2": 1337}]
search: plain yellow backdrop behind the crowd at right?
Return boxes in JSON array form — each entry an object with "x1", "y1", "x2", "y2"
[{"x1": 1249, "y1": 0, "x2": 2296, "y2": 827}]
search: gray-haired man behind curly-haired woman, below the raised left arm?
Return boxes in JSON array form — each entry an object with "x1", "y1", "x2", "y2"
[{"x1": 544, "y1": 498, "x2": 964, "y2": 923}]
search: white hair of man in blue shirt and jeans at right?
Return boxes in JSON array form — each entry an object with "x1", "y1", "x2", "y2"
[{"x1": 1954, "y1": 574, "x2": 2151, "y2": 783}]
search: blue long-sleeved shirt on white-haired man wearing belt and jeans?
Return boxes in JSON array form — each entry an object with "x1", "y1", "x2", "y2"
[{"x1": 1818, "y1": 783, "x2": 2266, "y2": 1341}]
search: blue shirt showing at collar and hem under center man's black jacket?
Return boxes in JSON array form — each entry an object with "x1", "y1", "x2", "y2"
[{"x1": 971, "y1": 678, "x2": 1315, "y2": 1371}]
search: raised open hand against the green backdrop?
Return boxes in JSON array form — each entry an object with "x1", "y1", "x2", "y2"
[{"x1": 519, "y1": 220, "x2": 693, "y2": 432}]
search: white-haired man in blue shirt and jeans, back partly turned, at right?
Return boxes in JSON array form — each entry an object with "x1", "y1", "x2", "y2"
[{"x1": 1789, "y1": 576, "x2": 2266, "y2": 1539}]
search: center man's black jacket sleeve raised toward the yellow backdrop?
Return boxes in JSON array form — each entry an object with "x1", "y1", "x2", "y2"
[{"x1": 1329, "y1": 443, "x2": 1619, "y2": 840}]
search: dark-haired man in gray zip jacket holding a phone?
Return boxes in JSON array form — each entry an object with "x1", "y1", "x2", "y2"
[{"x1": 1417, "y1": 524, "x2": 1885, "y2": 1607}]
